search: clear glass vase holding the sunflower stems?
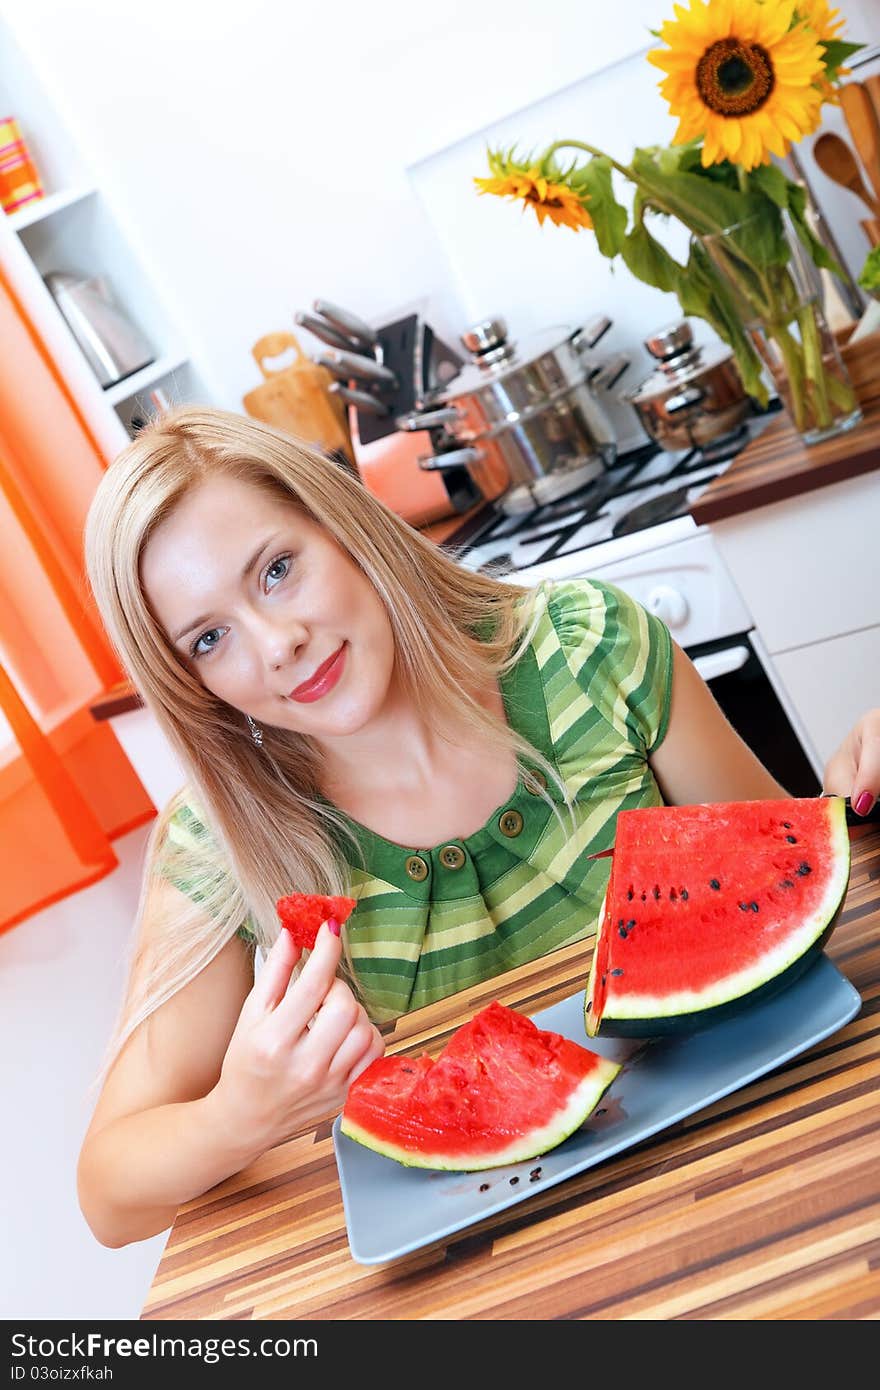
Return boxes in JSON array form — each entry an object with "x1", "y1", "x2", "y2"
[{"x1": 699, "y1": 213, "x2": 862, "y2": 445}]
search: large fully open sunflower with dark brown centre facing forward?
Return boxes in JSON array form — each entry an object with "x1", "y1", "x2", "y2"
[{"x1": 648, "y1": 0, "x2": 824, "y2": 170}]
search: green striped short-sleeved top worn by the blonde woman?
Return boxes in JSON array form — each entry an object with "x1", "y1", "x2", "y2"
[{"x1": 163, "y1": 578, "x2": 671, "y2": 1022}]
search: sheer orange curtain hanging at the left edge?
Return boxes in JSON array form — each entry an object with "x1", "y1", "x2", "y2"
[{"x1": 0, "y1": 262, "x2": 156, "y2": 931}]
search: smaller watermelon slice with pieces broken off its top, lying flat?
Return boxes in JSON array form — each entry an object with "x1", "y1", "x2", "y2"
[{"x1": 341, "y1": 1001, "x2": 620, "y2": 1172}]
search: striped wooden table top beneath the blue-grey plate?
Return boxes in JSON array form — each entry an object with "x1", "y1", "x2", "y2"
[{"x1": 142, "y1": 826, "x2": 880, "y2": 1321}]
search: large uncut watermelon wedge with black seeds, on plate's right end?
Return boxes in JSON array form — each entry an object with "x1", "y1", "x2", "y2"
[{"x1": 585, "y1": 796, "x2": 849, "y2": 1037}]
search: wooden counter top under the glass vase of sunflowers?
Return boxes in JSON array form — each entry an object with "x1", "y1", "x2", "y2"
[{"x1": 691, "y1": 334, "x2": 880, "y2": 525}]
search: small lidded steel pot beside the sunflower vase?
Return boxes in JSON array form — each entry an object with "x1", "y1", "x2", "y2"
[{"x1": 624, "y1": 318, "x2": 751, "y2": 452}]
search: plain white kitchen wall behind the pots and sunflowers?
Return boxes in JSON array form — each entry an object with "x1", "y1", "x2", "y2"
[{"x1": 6, "y1": 0, "x2": 880, "y2": 447}]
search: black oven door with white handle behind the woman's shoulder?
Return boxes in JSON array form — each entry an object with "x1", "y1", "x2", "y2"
[{"x1": 684, "y1": 632, "x2": 822, "y2": 796}]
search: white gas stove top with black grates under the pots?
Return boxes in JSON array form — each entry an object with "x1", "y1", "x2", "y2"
[{"x1": 443, "y1": 409, "x2": 774, "y2": 578}]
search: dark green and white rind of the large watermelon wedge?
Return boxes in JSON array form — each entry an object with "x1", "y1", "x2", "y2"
[{"x1": 585, "y1": 799, "x2": 851, "y2": 1037}]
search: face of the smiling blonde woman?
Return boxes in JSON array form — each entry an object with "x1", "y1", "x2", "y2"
[{"x1": 140, "y1": 475, "x2": 395, "y2": 742}]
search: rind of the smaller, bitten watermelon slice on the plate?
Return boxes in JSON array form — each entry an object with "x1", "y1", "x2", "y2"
[{"x1": 339, "y1": 1056, "x2": 620, "y2": 1173}]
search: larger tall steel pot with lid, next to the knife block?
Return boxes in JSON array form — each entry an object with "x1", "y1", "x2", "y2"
[{"x1": 400, "y1": 318, "x2": 617, "y2": 510}]
